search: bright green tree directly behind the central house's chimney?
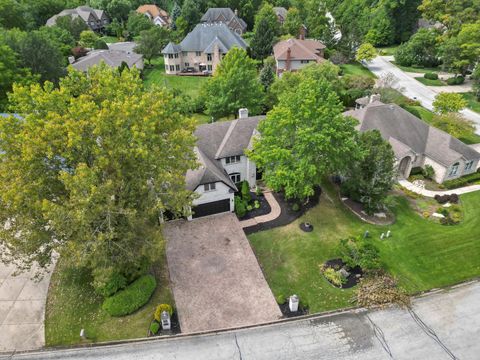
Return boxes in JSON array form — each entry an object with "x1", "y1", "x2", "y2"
[{"x1": 202, "y1": 47, "x2": 264, "y2": 119}]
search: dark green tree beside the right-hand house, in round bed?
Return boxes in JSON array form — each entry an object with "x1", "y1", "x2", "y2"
[{"x1": 342, "y1": 130, "x2": 395, "y2": 214}]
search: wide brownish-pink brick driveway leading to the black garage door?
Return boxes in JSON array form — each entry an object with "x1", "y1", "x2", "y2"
[{"x1": 164, "y1": 213, "x2": 282, "y2": 333}]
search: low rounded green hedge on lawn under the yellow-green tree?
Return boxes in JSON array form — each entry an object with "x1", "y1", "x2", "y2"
[{"x1": 102, "y1": 275, "x2": 157, "y2": 316}]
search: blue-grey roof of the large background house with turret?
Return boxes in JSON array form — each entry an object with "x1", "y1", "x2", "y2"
[{"x1": 162, "y1": 23, "x2": 247, "y2": 54}]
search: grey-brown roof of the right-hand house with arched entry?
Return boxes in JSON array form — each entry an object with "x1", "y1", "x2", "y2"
[{"x1": 345, "y1": 100, "x2": 480, "y2": 167}]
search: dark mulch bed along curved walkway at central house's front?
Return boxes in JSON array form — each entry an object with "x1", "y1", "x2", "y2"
[{"x1": 243, "y1": 187, "x2": 322, "y2": 235}]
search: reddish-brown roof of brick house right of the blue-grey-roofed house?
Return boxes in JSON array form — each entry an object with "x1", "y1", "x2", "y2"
[{"x1": 273, "y1": 38, "x2": 325, "y2": 62}]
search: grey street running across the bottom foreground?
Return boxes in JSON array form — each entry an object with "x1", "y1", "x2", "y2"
[{"x1": 0, "y1": 282, "x2": 480, "y2": 360}]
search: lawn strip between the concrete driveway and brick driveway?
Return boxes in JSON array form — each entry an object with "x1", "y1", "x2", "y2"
[{"x1": 45, "y1": 250, "x2": 174, "y2": 346}]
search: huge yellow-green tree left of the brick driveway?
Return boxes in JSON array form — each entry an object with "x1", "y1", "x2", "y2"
[{"x1": 0, "y1": 65, "x2": 196, "y2": 278}]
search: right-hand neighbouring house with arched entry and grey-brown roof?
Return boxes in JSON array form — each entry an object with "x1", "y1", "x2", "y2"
[{"x1": 345, "y1": 99, "x2": 480, "y2": 184}]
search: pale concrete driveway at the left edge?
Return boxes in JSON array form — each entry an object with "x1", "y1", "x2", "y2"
[{"x1": 0, "y1": 262, "x2": 51, "y2": 352}]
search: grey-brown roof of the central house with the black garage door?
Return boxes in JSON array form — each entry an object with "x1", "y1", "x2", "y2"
[{"x1": 186, "y1": 116, "x2": 265, "y2": 191}]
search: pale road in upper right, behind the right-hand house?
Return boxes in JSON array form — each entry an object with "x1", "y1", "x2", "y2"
[{"x1": 366, "y1": 56, "x2": 480, "y2": 134}]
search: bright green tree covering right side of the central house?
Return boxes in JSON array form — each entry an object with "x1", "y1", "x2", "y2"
[{"x1": 249, "y1": 76, "x2": 355, "y2": 199}]
